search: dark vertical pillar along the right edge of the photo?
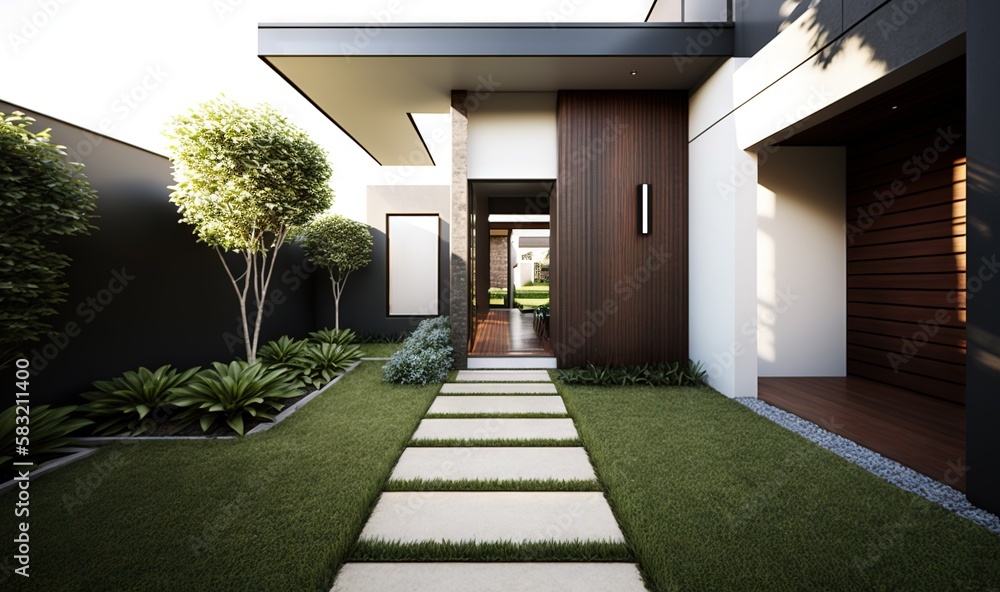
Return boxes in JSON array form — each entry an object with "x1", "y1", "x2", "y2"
[{"x1": 965, "y1": 0, "x2": 1000, "y2": 513}]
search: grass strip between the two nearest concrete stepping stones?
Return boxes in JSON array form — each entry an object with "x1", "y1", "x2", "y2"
[{"x1": 351, "y1": 540, "x2": 634, "y2": 562}]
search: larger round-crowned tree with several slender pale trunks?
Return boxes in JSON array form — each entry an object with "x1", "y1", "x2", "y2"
[{"x1": 167, "y1": 98, "x2": 333, "y2": 362}]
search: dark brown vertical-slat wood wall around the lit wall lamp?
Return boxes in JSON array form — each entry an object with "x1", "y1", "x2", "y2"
[{"x1": 551, "y1": 91, "x2": 688, "y2": 367}]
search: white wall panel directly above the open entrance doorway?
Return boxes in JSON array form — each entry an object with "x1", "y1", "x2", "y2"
[{"x1": 469, "y1": 92, "x2": 559, "y2": 180}]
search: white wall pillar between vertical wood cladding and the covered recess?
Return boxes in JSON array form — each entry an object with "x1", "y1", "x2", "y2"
[{"x1": 688, "y1": 59, "x2": 757, "y2": 397}]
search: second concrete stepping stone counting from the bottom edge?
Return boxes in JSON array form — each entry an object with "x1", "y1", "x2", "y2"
[{"x1": 361, "y1": 491, "x2": 625, "y2": 543}]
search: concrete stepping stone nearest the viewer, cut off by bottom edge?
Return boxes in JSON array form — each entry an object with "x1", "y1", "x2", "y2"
[{"x1": 331, "y1": 563, "x2": 646, "y2": 592}]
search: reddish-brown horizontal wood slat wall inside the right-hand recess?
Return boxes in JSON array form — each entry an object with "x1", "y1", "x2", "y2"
[{"x1": 847, "y1": 93, "x2": 966, "y2": 404}]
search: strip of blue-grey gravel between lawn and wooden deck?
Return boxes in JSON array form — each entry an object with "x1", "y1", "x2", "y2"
[{"x1": 736, "y1": 397, "x2": 1000, "y2": 534}]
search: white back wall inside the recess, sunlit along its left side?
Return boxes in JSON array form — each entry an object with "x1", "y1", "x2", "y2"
[{"x1": 756, "y1": 146, "x2": 847, "y2": 376}]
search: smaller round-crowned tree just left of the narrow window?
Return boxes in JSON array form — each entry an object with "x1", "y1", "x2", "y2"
[{"x1": 301, "y1": 214, "x2": 372, "y2": 329}]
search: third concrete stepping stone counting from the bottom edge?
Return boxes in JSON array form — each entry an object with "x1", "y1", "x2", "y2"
[{"x1": 392, "y1": 446, "x2": 597, "y2": 481}]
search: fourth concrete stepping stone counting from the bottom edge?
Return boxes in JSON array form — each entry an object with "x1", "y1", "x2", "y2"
[{"x1": 413, "y1": 418, "x2": 579, "y2": 440}]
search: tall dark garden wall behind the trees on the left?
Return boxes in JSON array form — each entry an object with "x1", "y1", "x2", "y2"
[{"x1": 0, "y1": 102, "x2": 315, "y2": 404}]
